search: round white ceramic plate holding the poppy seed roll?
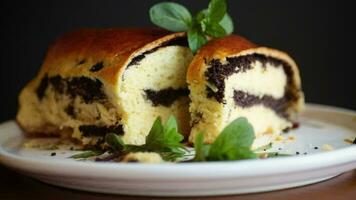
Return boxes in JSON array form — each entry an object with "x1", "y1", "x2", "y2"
[{"x1": 0, "y1": 105, "x2": 356, "y2": 196}]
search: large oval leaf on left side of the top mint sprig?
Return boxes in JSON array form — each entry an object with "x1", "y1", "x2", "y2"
[{"x1": 149, "y1": 2, "x2": 192, "y2": 32}]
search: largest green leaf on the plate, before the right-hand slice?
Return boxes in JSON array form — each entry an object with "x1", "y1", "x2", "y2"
[{"x1": 208, "y1": 117, "x2": 256, "y2": 160}]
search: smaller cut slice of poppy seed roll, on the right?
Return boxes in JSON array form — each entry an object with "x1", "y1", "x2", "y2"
[{"x1": 187, "y1": 35, "x2": 304, "y2": 149}]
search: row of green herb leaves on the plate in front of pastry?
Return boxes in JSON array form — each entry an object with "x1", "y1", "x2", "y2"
[{"x1": 70, "y1": 116, "x2": 292, "y2": 162}]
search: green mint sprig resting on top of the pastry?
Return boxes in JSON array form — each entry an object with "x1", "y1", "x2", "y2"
[{"x1": 149, "y1": 0, "x2": 234, "y2": 53}]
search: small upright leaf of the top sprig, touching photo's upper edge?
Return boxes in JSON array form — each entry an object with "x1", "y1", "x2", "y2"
[{"x1": 207, "y1": 0, "x2": 227, "y2": 23}]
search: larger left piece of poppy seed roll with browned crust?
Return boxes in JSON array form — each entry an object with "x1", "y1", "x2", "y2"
[{"x1": 17, "y1": 29, "x2": 193, "y2": 145}]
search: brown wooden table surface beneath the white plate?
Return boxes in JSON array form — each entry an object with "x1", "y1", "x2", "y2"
[{"x1": 0, "y1": 166, "x2": 356, "y2": 200}]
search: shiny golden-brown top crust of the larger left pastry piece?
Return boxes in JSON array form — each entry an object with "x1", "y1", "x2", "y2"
[{"x1": 35, "y1": 28, "x2": 184, "y2": 85}]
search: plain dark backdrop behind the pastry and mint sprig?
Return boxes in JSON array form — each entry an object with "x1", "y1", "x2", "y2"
[{"x1": 0, "y1": 0, "x2": 356, "y2": 121}]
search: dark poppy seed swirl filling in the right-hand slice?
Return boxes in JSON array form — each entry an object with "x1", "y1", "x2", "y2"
[{"x1": 205, "y1": 53, "x2": 298, "y2": 118}]
